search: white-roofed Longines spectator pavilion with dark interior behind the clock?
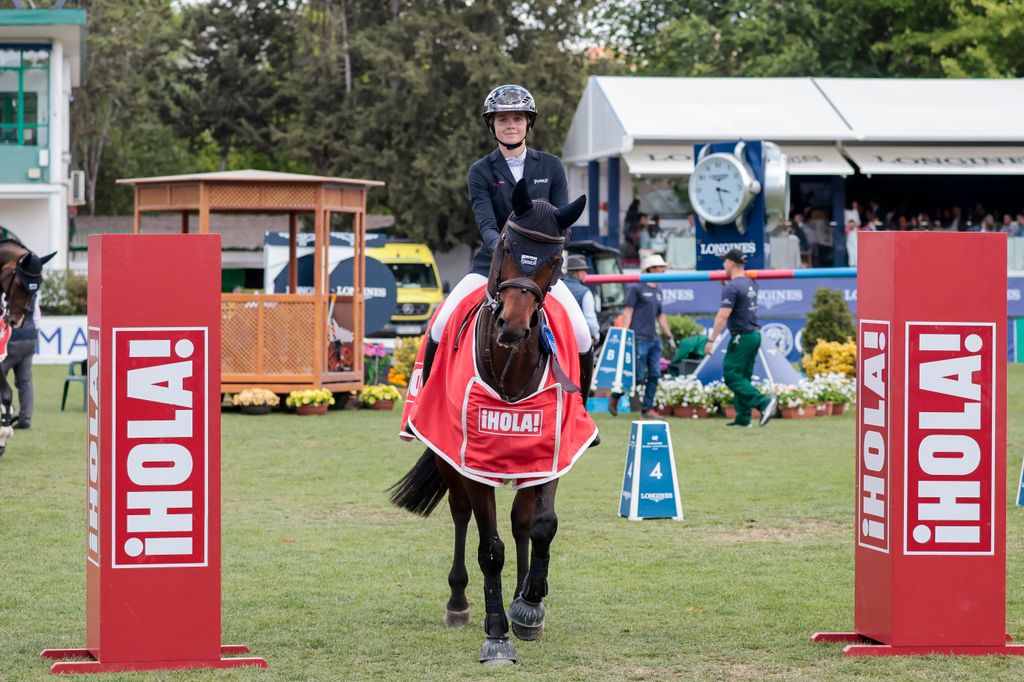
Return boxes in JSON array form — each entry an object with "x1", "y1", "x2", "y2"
[{"x1": 562, "y1": 77, "x2": 1024, "y2": 269}]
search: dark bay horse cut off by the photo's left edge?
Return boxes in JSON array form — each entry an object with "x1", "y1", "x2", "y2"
[{"x1": 0, "y1": 240, "x2": 56, "y2": 455}]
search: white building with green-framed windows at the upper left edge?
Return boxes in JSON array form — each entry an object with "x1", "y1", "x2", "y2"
[{"x1": 0, "y1": 9, "x2": 85, "y2": 268}]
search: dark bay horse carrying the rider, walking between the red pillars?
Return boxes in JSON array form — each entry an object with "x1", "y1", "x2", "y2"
[{"x1": 390, "y1": 180, "x2": 598, "y2": 665}]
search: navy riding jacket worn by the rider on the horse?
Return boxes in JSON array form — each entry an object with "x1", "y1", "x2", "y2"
[{"x1": 467, "y1": 147, "x2": 569, "y2": 276}]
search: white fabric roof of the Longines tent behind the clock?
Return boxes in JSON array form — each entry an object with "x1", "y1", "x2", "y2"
[{"x1": 562, "y1": 76, "x2": 1024, "y2": 175}]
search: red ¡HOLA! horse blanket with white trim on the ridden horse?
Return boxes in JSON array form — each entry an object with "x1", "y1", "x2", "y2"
[{"x1": 401, "y1": 287, "x2": 597, "y2": 488}]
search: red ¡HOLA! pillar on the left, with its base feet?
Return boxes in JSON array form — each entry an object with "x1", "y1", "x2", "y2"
[{"x1": 42, "y1": 235, "x2": 266, "y2": 673}]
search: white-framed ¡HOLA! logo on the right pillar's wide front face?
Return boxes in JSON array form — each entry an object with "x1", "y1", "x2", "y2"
[{"x1": 903, "y1": 322, "x2": 995, "y2": 555}]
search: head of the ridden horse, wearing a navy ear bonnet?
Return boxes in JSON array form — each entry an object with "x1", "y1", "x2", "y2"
[{"x1": 487, "y1": 180, "x2": 587, "y2": 346}]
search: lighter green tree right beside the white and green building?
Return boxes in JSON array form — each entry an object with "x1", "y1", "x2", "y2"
[{"x1": 71, "y1": 0, "x2": 177, "y2": 214}]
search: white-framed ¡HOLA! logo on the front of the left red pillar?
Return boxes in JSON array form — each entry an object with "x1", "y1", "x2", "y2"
[{"x1": 111, "y1": 328, "x2": 209, "y2": 567}]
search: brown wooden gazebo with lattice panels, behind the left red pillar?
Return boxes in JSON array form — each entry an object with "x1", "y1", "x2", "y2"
[{"x1": 118, "y1": 170, "x2": 384, "y2": 393}]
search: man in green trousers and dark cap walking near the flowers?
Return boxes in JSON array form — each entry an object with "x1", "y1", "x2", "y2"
[{"x1": 705, "y1": 249, "x2": 778, "y2": 427}]
